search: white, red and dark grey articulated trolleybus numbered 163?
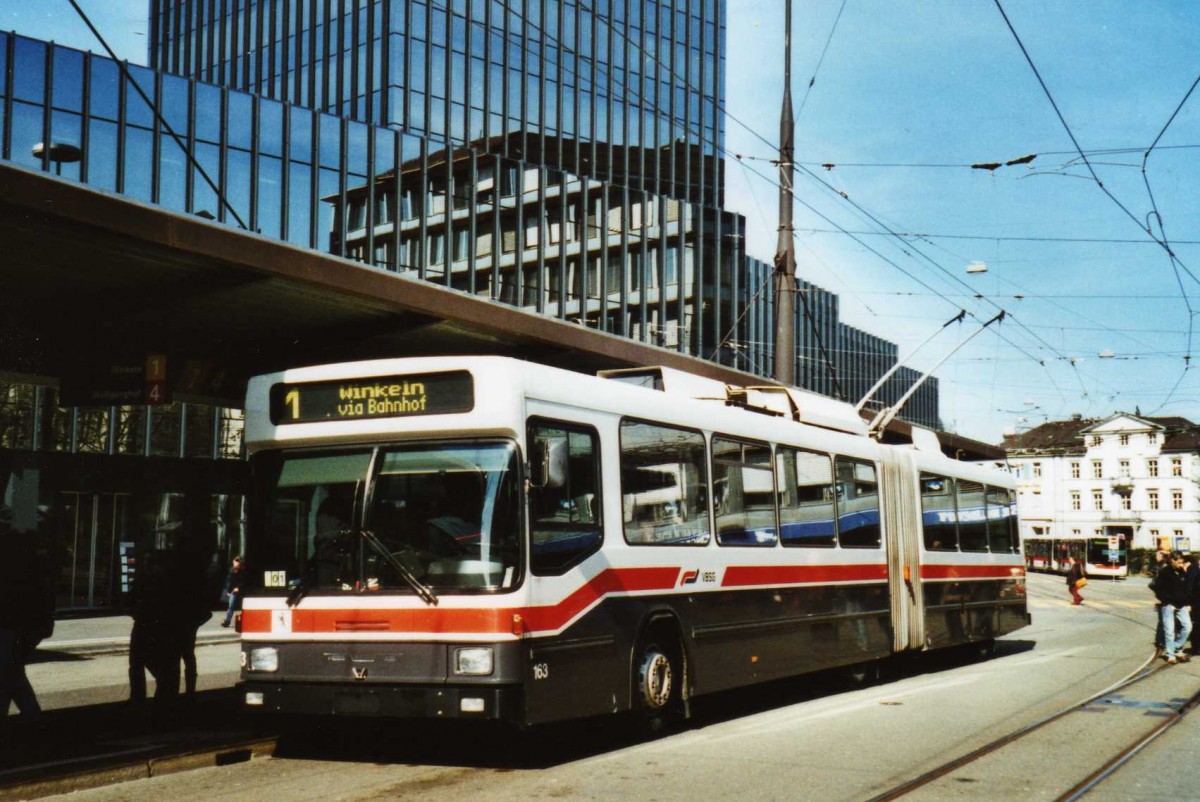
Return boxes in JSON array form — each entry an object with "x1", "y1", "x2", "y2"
[{"x1": 240, "y1": 357, "x2": 1028, "y2": 725}]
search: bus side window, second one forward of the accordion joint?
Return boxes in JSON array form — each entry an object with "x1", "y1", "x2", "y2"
[{"x1": 775, "y1": 448, "x2": 838, "y2": 546}]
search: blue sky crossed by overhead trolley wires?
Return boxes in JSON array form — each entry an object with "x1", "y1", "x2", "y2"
[{"x1": 0, "y1": 0, "x2": 1200, "y2": 442}]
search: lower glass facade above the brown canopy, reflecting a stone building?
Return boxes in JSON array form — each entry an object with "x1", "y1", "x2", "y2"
[{"x1": 0, "y1": 22, "x2": 937, "y2": 420}]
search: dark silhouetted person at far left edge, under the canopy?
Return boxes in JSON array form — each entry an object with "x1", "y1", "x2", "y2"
[{"x1": 0, "y1": 504, "x2": 54, "y2": 731}]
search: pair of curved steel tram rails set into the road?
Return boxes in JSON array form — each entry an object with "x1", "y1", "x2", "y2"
[{"x1": 868, "y1": 654, "x2": 1200, "y2": 802}]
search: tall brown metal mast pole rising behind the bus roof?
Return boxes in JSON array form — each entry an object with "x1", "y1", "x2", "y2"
[{"x1": 775, "y1": 0, "x2": 796, "y2": 385}]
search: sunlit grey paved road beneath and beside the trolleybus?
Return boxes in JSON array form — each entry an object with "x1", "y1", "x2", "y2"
[{"x1": 25, "y1": 575, "x2": 1200, "y2": 802}]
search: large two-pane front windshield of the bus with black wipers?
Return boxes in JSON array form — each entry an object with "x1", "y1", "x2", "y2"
[{"x1": 247, "y1": 442, "x2": 521, "y2": 593}]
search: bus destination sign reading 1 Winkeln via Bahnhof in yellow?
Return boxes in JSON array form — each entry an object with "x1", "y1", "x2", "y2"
[{"x1": 271, "y1": 371, "x2": 475, "y2": 424}]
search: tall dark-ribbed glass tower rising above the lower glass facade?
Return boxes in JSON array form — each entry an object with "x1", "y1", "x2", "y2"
[{"x1": 150, "y1": 0, "x2": 725, "y2": 207}]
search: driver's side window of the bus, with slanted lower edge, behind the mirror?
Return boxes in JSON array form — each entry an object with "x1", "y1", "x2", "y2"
[{"x1": 527, "y1": 420, "x2": 602, "y2": 574}]
